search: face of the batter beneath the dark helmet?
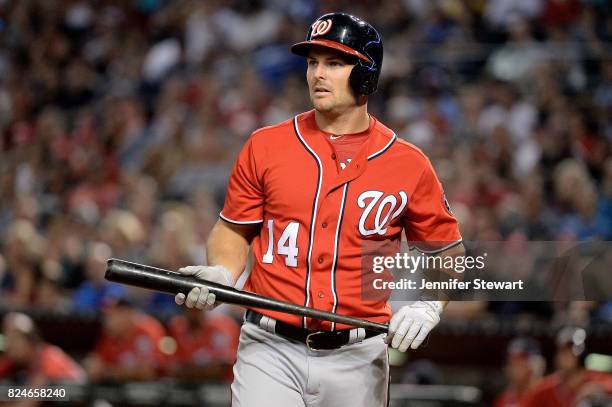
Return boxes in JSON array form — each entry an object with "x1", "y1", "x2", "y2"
[{"x1": 306, "y1": 47, "x2": 356, "y2": 113}]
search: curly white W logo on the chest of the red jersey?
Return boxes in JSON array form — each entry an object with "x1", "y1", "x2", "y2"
[{"x1": 357, "y1": 191, "x2": 408, "y2": 236}]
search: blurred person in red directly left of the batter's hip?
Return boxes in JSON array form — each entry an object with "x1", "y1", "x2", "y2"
[{"x1": 169, "y1": 308, "x2": 240, "y2": 381}]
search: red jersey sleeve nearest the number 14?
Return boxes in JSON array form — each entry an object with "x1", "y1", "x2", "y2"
[{"x1": 219, "y1": 137, "x2": 264, "y2": 224}]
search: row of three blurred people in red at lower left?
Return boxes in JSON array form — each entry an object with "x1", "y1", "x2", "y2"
[{"x1": 0, "y1": 306, "x2": 240, "y2": 386}]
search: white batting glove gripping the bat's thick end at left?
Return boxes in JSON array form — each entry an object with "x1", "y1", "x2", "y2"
[{"x1": 174, "y1": 266, "x2": 236, "y2": 311}]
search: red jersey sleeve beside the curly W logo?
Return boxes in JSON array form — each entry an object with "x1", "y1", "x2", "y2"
[{"x1": 403, "y1": 160, "x2": 461, "y2": 253}]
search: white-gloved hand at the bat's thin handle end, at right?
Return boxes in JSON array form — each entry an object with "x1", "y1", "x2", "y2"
[{"x1": 385, "y1": 301, "x2": 442, "y2": 352}]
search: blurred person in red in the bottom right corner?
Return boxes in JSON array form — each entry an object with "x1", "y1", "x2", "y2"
[{"x1": 522, "y1": 327, "x2": 612, "y2": 407}]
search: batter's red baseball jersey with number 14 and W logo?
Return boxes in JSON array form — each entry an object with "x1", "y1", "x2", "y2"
[{"x1": 220, "y1": 111, "x2": 461, "y2": 330}]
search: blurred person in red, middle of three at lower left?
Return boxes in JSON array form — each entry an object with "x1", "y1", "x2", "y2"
[{"x1": 85, "y1": 298, "x2": 165, "y2": 382}]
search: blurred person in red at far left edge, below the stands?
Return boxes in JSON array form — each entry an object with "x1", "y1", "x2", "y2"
[{"x1": 0, "y1": 312, "x2": 86, "y2": 387}]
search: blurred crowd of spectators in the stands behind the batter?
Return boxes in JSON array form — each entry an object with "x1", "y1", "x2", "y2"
[{"x1": 0, "y1": 0, "x2": 612, "y2": 402}]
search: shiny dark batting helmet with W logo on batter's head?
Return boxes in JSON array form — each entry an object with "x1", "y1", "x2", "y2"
[{"x1": 291, "y1": 13, "x2": 383, "y2": 95}]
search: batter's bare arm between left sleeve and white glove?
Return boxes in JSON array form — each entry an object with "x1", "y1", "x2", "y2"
[{"x1": 206, "y1": 220, "x2": 253, "y2": 281}]
